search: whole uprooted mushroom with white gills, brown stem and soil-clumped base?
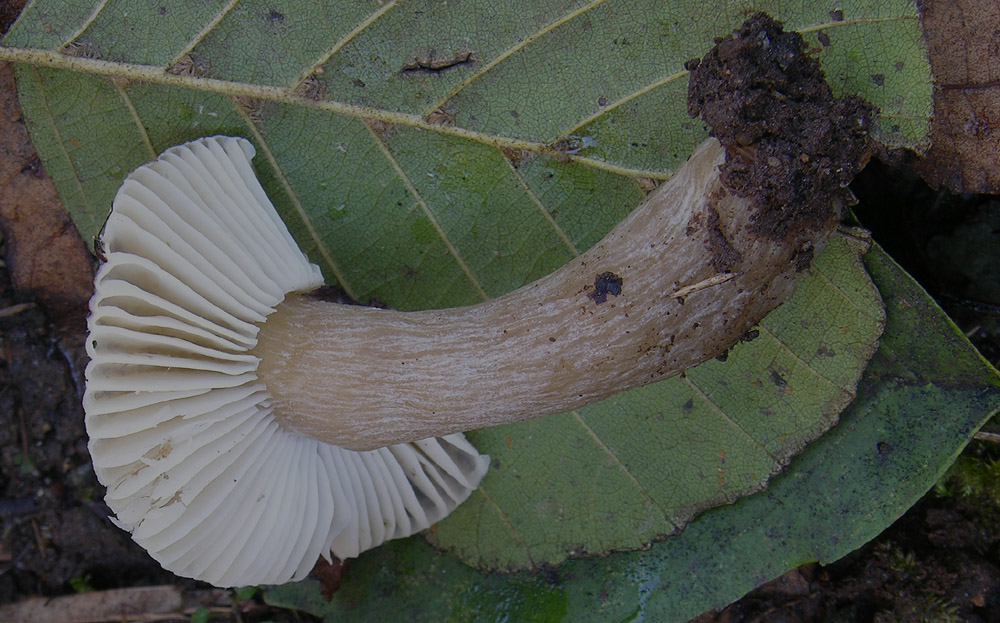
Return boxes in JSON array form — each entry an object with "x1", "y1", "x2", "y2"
[{"x1": 84, "y1": 16, "x2": 872, "y2": 586}]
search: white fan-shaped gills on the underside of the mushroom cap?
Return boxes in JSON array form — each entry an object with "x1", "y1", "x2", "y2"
[{"x1": 84, "y1": 136, "x2": 487, "y2": 586}]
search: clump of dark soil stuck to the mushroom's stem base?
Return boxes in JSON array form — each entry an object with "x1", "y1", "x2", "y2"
[{"x1": 687, "y1": 13, "x2": 877, "y2": 239}]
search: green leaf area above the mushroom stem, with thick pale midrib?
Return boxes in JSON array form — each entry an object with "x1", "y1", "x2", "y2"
[{"x1": 0, "y1": 0, "x2": 931, "y2": 256}]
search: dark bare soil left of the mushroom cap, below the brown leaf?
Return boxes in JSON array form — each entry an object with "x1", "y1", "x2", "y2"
[{"x1": 0, "y1": 256, "x2": 186, "y2": 603}]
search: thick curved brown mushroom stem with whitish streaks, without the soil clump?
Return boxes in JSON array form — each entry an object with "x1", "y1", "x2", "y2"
[{"x1": 253, "y1": 139, "x2": 839, "y2": 450}]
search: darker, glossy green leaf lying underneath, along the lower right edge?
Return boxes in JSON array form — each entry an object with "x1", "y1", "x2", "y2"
[{"x1": 266, "y1": 249, "x2": 1000, "y2": 623}]
